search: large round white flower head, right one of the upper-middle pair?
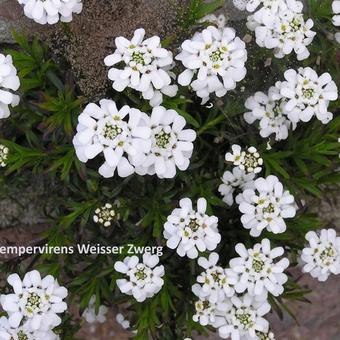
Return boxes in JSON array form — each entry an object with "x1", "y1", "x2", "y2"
[{"x1": 176, "y1": 26, "x2": 247, "y2": 104}]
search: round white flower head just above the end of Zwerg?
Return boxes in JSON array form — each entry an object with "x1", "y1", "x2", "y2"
[{"x1": 163, "y1": 198, "x2": 221, "y2": 259}]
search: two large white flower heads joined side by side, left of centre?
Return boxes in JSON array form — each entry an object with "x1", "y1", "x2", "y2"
[{"x1": 73, "y1": 99, "x2": 196, "y2": 178}]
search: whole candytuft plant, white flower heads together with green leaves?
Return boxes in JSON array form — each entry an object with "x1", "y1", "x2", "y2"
[{"x1": 0, "y1": 0, "x2": 340, "y2": 340}]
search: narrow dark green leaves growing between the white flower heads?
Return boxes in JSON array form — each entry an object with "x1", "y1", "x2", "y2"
[{"x1": 0, "y1": 0, "x2": 340, "y2": 340}]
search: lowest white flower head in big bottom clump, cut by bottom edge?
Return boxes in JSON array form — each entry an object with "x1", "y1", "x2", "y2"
[{"x1": 212, "y1": 294, "x2": 270, "y2": 340}]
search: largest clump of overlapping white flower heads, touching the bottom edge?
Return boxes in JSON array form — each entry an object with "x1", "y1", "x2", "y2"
[{"x1": 192, "y1": 239, "x2": 289, "y2": 340}]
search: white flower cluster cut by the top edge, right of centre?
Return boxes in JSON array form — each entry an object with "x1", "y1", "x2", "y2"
[{"x1": 239, "y1": 0, "x2": 316, "y2": 60}]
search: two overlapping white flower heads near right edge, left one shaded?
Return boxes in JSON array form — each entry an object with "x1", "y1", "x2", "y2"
[{"x1": 244, "y1": 67, "x2": 338, "y2": 140}]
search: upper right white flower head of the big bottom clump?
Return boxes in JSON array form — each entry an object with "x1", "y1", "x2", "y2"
[{"x1": 229, "y1": 238, "x2": 289, "y2": 297}]
